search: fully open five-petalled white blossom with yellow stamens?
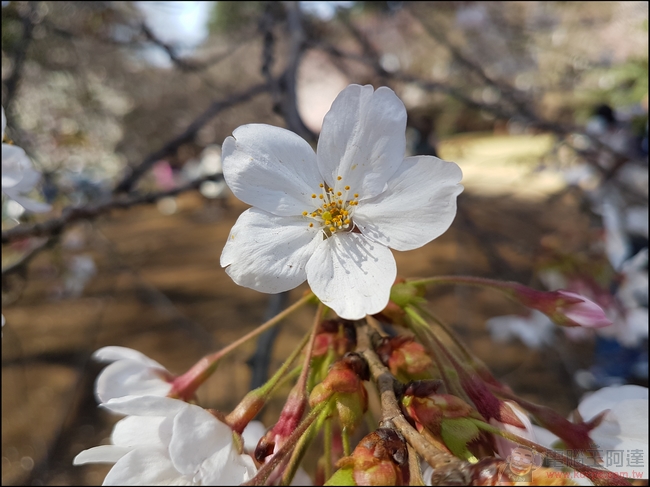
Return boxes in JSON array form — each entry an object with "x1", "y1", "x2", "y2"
[{"x1": 221, "y1": 85, "x2": 463, "y2": 319}]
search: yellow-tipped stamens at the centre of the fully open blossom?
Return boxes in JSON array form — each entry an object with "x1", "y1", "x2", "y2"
[{"x1": 302, "y1": 176, "x2": 359, "y2": 237}]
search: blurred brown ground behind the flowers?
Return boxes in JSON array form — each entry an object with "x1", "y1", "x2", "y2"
[{"x1": 2, "y1": 180, "x2": 604, "y2": 485}]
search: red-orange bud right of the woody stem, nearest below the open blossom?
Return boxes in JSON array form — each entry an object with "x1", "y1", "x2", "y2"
[{"x1": 375, "y1": 336, "x2": 432, "y2": 382}]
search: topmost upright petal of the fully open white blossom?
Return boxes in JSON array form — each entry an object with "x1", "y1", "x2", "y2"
[{"x1": 317, "y1": 85, "x2": 406, "y2": 199}]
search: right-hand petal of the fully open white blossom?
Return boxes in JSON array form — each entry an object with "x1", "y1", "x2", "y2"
[{"x1": 354, "y1": 156, "x2": 463, "y2": 250}]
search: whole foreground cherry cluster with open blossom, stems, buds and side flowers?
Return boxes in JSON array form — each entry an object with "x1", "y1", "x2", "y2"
[{"x1": 74, "y1": 85, "x2": 647, "y2": 485}]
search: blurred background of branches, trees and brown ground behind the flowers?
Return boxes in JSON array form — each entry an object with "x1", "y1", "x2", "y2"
[{"x1": 2, "y1": 1, "x2": 648, "y2": 485}]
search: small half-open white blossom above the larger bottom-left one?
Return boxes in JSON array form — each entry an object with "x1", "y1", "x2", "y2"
[{"x1": 93, "y1": 347, "x2": 173, "y2": 403}]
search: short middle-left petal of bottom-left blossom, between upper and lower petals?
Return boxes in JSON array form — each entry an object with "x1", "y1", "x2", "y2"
[{"x1": 111, "y1": 416, "x2": 172, "y2": 448}]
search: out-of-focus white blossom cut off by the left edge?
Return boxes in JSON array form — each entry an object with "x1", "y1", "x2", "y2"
[{"x1": 2, "y1": 108, "x2": 52, "y2": 213}]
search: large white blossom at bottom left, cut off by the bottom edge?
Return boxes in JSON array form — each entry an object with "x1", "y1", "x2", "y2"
[{"x1": 73, "y1": 396, "x2": 256, "y2": 485}]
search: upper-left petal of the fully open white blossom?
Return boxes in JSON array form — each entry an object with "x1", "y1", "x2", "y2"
[{"x1": 222, "y1": 124, "x2": 323, "y2": 216}]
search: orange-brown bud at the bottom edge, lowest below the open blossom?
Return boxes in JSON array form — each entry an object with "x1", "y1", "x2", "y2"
[{"x1": 337, "y1": 428, "x2": 409, "y2": 485}]
